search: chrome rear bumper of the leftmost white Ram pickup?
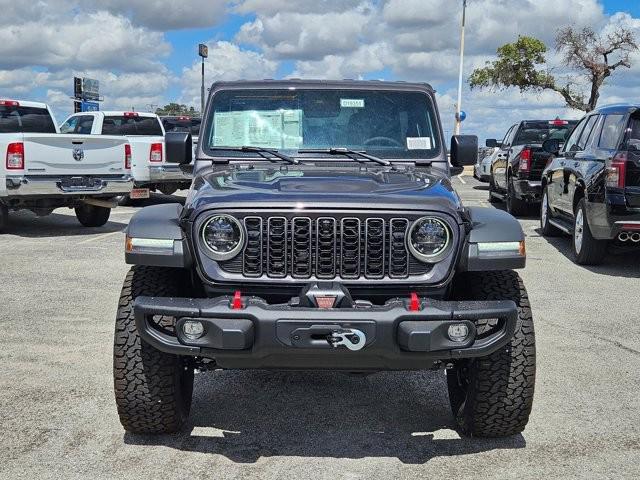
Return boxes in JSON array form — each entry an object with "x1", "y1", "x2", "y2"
[{"x1": 6, "y1": 175, "x2": 133, "y2": 198}]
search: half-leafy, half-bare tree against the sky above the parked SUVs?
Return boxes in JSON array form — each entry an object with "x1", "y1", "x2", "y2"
[{"x1": 469, "y1": 26, "x2": 638, "y2": 112}]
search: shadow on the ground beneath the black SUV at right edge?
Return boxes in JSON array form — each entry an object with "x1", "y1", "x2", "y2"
[{"x1": 536, "y1": 228, "x2": 640, "y2": 278}]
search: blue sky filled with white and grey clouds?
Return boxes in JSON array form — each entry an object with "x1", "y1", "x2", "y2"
[{"x1": 0, "y1": 0, "x2": 640, "y2": 139}]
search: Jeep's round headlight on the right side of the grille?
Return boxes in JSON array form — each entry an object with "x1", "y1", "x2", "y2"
[{"x1": 407, "y1": 217, "x2": 451, "y2": 262}]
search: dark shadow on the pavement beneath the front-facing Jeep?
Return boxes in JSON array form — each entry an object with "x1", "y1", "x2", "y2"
[{"x1": 124, "y1": 371, "x2": 526, "y2": 464}]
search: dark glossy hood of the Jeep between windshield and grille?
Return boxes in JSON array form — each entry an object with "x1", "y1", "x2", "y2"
[{"x1": 187, "y1": 165, "x2": 460, "y2": 210}]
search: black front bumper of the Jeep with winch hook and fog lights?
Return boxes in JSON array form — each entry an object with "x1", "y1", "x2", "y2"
[{"x1": 134, "y1": 296, "x2": 517, "y2": 371}]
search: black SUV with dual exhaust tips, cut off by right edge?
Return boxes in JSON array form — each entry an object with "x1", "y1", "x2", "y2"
[{"x1": 540, "y1": 104, "x2": 640, "y2": 265}]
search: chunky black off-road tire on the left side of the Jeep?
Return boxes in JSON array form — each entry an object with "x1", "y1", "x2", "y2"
[{"x1": 113, "y1": 266, "x2": 193, "y2": 433}]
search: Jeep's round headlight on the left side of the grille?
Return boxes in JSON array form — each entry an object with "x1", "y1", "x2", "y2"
[{"x1": 202, "y1": 215, "x2": 244, "y2": 260}]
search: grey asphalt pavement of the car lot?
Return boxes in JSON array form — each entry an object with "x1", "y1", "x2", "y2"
[{"x1": 0, "y1": 176, "x2": 640, "y2": 479}]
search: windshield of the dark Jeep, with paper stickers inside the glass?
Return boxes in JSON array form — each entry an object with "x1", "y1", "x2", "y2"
[{"x1": 204, "y1": 89, "x2": 440, "y2": 159}]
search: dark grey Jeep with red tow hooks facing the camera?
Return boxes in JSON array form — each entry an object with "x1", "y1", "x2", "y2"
[{"x1": 114, "y1": 80, "x2": 535, "y2": 436}]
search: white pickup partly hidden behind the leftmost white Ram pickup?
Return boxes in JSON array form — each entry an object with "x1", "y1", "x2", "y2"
[{"x1": 60, "y1": 111, "x2": 191, "y2": 199}]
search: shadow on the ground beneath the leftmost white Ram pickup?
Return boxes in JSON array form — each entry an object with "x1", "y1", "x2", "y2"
[{"x1": 3, "y1": 210, "x2": 127, "y2": 238}]
